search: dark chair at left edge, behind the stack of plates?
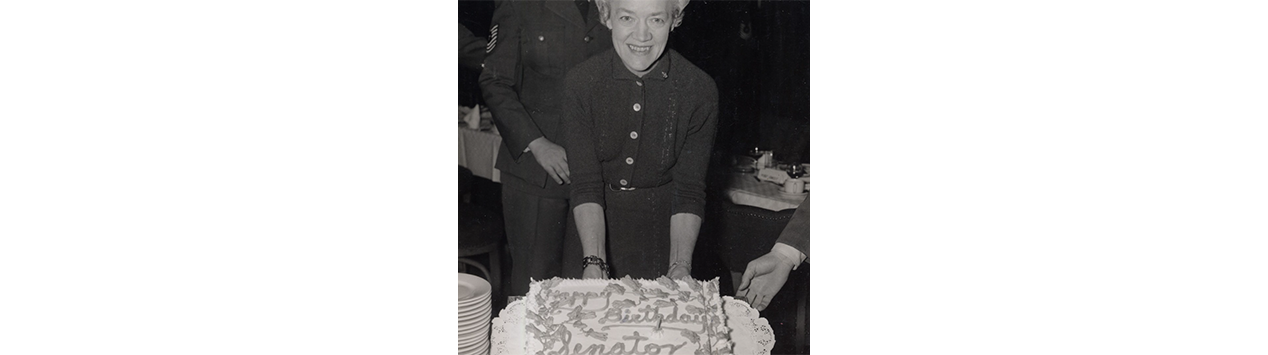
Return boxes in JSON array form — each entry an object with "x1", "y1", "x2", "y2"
[{"x1": 458, "y1": 166, "x2": 506, "y2": 307}]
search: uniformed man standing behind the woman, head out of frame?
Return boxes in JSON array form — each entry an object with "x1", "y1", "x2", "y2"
[{"x1": 481, "y1": 0, "x2": 612, "y2": 294}]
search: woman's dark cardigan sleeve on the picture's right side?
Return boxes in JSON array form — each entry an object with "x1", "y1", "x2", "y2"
[{"x1": 672, "y1": 80, "x2": 718, "y2": 218}]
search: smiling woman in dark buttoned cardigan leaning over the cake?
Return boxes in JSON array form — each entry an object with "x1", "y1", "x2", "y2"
[{"x1": 563, "y1": 0, "x2": 718, "y2": 279}]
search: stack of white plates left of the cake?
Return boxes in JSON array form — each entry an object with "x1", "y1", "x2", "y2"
[{"x1": 458, "y1": 273, "x2": 493, "y2": 355}]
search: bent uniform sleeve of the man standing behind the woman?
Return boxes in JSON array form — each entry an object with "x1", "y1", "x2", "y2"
[{"x1": 479, "y1": 1, "x2": 543, "y2": 160}]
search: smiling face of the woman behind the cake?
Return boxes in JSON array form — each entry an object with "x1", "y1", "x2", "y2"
[{"x1": 606, "y1": 0, "x2": 673, "y2": 77}]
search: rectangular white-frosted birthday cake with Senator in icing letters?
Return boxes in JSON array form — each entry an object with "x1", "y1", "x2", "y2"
[{"x1": 525, "y1": 276, "x2": 732, "y2": 355}]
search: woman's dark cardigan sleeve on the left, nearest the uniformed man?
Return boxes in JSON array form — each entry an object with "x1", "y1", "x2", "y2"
[{"x1": 563, "y1": 71, "x2": 606, "y2": 208}]
